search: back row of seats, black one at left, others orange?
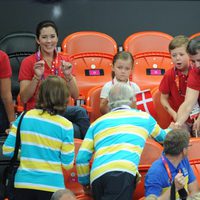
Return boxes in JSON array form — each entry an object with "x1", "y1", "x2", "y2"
[{"x1": 0, "y1": 31, "x2": 198, "y2": 121}]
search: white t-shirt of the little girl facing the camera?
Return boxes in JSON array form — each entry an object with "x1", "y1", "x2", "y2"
[{"x1": 100, "y1": 78, "x2": 140, "y2": 99}]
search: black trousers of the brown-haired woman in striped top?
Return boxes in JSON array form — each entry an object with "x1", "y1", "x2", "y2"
[{"x1": 15, "y1": 188, "x2": 53, "y2": 200}]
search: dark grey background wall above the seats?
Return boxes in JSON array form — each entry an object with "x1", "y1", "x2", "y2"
[{"x1": 0, "y1": 0, "x2": 200, "y2": 45}]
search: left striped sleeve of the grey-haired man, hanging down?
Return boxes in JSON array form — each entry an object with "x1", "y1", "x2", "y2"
[{"x1": 76, "y1": 126, "x2": 94, "y2": 185}]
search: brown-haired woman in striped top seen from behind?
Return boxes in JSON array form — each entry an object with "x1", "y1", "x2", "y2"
[{"x1": 3, "y1": 76, "x2": 74, "y2": 200}]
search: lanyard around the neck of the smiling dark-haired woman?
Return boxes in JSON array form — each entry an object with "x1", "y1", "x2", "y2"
[{"x1": 36, "y1": 50, "x2": 62, "y2": 76}]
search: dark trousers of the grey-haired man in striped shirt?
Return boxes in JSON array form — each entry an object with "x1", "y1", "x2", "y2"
[{"x1": 92, "y1": 171, "x2": 136, "y2": 200}]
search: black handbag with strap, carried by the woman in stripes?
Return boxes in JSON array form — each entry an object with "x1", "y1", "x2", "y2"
[{"x1": 0, "y1": 111, "x2": 26, "y2": 200}]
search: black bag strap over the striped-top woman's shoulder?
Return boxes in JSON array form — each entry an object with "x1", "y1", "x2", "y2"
[{"x1": 10, "y1": 111, "x2": 27, "y2": 168}]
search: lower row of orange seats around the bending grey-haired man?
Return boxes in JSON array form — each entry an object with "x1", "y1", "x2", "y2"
[{"x1": 64, "y1": 138, "x2": 200, "y2": 200}]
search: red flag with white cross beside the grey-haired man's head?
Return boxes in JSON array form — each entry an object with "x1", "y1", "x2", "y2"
[{"x1": 136, "y1": 89, "x2": 156, "y2": 117}]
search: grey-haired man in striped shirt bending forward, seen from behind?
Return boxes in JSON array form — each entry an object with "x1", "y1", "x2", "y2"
[{"x1": 76, "y1": 83, "x2": 170, "y2": 200}]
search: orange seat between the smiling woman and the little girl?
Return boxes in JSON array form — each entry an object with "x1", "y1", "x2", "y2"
[{"x1": 61, "y1": 31, "x2": 117, "y2": 99}]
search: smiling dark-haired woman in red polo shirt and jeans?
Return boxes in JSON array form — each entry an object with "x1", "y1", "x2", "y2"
[{"x1": 19, "y1": 21, "x2": 90, "y2": 138}]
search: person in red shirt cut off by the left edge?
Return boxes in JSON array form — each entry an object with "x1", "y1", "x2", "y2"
[{"x1": 0, "y1": 51, "x2": 15, "y2": 133}]
